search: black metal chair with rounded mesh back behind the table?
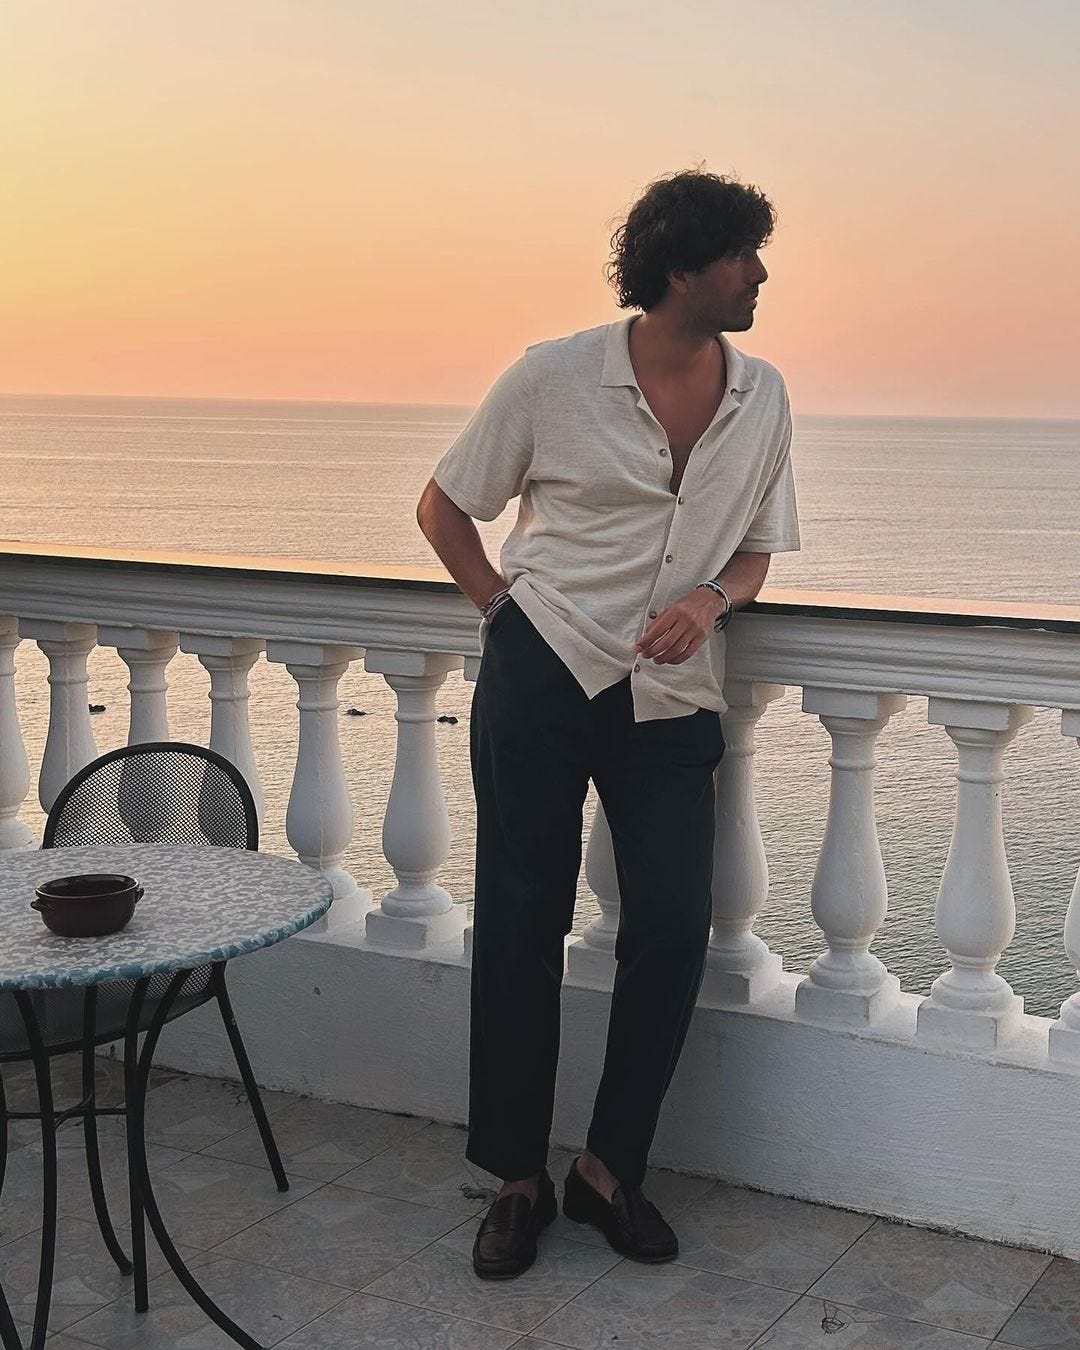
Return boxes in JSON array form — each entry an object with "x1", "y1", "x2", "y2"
[{"x1": 0, "y1": 741, "x2": 289, "y2": 1316}]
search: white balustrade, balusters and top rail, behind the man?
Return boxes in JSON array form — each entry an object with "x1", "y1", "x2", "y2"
[{"x1": 0, "y1": 542, "x2": 1080, "y2": 1064}]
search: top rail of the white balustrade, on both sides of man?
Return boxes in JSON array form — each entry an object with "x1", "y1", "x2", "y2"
[{"x1": 0, "y1": 543, "x2": 1080, "y2": 710}]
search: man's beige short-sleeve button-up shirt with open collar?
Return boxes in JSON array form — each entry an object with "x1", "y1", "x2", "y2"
[{"x1": 432, "y1": 317, "x2": 799, "y2": 722}]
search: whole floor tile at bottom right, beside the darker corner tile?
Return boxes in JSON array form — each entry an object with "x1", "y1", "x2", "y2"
[{"x1": 810, "y1": 1219, "x2": 1050, "y2": 1338}]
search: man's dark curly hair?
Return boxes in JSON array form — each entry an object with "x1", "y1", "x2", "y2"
[{"x1": 606, "y1": 169, "x2": 776, "y2": 311}]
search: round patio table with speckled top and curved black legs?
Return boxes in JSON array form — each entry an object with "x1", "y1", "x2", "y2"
[{"x1": 0, "y1": 844, "x2": 333, "y2": 1350}]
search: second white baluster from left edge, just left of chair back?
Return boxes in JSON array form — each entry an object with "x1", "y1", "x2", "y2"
[{"x1": 19, "y1": 618, "x2": 97, "y2": 813}]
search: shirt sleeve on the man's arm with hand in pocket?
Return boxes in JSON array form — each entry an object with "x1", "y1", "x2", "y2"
[{"x1": 432, "y1": 356, "x2": 533, "y2": 520}]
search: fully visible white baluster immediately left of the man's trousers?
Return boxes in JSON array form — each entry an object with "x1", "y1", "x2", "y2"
[{"x1": 365, "y1": 648, "x2": 466, "y2": 950}]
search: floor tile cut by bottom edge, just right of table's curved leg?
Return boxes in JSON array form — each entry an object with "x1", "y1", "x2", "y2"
[{"x1": 282, "y1": 1293, "x2": 521, "y2": 1350}]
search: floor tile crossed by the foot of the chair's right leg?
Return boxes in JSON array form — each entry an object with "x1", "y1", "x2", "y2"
[{"x1": 204, "y1": 1098, "x2": 429, "y2": 1181}]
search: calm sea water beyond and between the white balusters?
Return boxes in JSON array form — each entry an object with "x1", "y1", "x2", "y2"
[{"x1": 0, "y1": 398, "x2": 1080, "y2": 1015}]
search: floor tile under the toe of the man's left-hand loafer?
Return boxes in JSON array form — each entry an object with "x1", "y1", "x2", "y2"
[{"x1": 365, "y1": 1224, "x2": 620, "y2": 1332}]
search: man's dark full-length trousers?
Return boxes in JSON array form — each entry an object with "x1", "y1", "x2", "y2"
[{"x1": 466, "y1": 601, "x2": 724, "y2": 1187}]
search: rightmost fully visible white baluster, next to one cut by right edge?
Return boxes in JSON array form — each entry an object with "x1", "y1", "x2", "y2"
[{"x1": 915, "y1": 698, "x2": 1033, "y2": 1049}]
